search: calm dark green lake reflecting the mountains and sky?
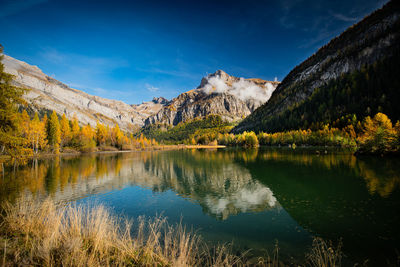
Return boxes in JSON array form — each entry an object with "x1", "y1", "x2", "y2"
[{"x1": 0, "y1": 149, "x2": 400, "y2": 266}]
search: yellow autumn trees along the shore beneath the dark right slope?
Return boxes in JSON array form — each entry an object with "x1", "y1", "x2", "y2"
[{"x1": 177, "y1": 113, "x2": 400, "y2": 154}]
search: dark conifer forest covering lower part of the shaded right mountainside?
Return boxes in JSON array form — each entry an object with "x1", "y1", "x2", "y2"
[{"x1": 241, "y1": 47, "x2": 400, "y2": 136}]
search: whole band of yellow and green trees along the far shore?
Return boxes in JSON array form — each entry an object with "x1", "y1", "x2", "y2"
[{"x1": 0, "y1": 45, "x2": 400, "y2": 164}]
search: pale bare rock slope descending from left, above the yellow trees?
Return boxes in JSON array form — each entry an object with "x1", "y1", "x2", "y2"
[{"x1": 2, "y1": 55, "x2": 168, "y2": 130}]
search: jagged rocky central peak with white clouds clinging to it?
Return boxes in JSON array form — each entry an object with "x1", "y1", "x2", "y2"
[{"x1": 145, "y1": 70, "x2": 279, "y2": 125}]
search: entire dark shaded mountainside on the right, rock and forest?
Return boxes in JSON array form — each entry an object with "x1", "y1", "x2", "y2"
[{"x1": 234, "y1": 1, "x2": 400, "y2": 132}]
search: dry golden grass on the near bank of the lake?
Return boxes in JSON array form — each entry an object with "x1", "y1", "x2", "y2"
[{"x1": 0, "y1": 198, "x2": 341, "y2": 266}]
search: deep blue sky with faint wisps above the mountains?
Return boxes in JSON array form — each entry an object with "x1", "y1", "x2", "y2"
[{"x1": 0, "y1": 0, "x2": 387, "y2": 104}]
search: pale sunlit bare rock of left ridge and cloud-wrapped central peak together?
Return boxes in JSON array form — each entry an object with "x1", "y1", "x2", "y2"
[{"x1": 2, "y1": 55, "x2": 279, "y2": 131}]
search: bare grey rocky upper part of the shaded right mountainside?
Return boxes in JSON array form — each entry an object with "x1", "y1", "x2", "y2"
[{"x1": 234, "y1": 1, "x2": 400, "y2": 132}]
